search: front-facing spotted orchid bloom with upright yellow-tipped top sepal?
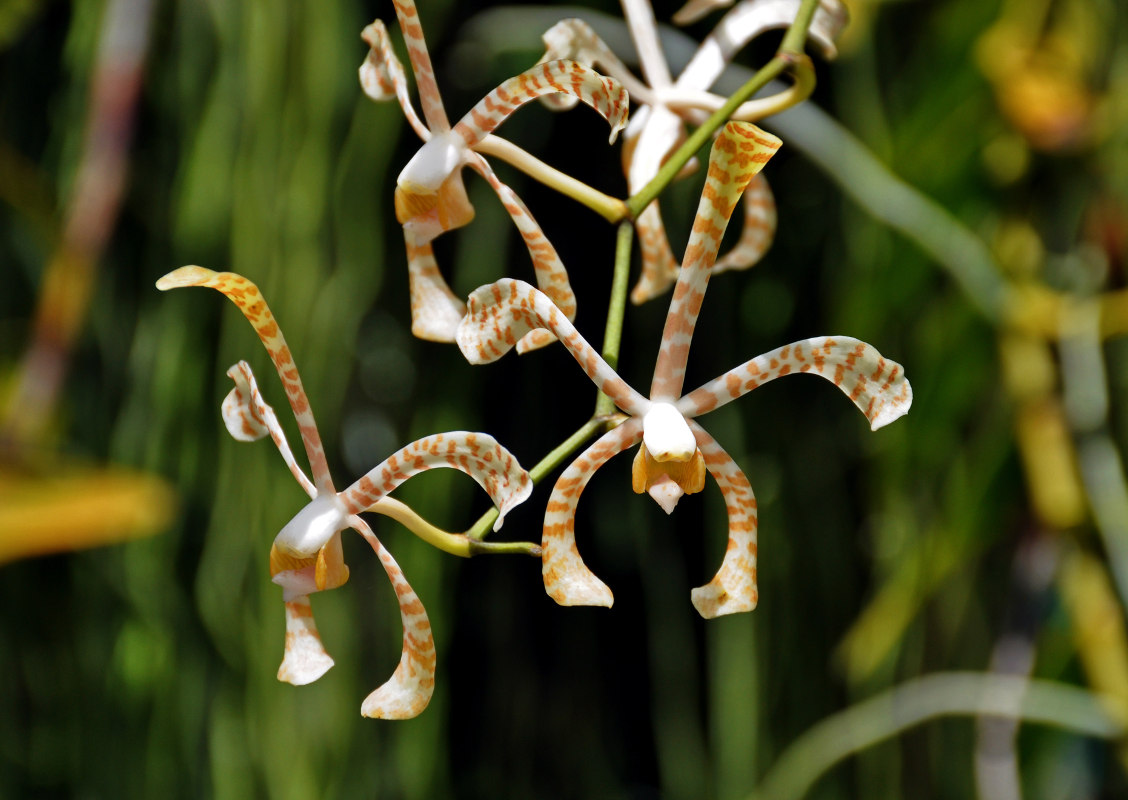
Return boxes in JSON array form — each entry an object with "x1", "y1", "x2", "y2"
[{"x1": 458, "y1": 122, "x2": 913, "y2": 618}]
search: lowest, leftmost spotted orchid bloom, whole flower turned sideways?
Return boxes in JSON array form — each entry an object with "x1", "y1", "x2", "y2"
[{"x1": 157, "y1": 266, "x2": 532, "y2": 719}]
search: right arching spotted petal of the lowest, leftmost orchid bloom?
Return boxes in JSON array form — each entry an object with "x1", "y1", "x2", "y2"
[{"x1": 340, "y1": 431, "x2": 532, "y2": 530}]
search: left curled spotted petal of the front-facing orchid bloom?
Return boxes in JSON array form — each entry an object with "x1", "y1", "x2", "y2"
[{"x1": 456, "y1": 278, "x2": 650, "y2": 414}]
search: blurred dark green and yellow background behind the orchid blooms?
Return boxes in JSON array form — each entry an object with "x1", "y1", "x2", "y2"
[{"x1": 0, "y1": 0, "x2": 1128, "y2": 800}]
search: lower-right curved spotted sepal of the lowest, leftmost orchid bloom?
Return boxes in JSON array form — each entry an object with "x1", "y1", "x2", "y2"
[{"x1": 350, "y1": 517, "x2": 435, "y2": 720}]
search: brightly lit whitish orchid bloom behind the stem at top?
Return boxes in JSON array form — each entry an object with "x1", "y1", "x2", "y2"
[{"x1": 544, "y1": 0, "x2": 848, "y2": 304}]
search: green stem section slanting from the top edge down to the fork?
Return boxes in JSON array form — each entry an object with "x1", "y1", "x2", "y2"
[{"x1": 627, "y1": 0, "x2": 819, "y2": 219}]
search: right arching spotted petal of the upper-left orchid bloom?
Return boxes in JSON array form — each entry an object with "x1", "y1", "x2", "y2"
[{"x1": 455, "y1": 60, "x2": 629, "y2": 147}]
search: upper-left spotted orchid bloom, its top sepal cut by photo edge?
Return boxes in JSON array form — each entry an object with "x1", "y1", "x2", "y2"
[{"x1": 360, "y1": 0, "x2": 629, "y2": 352}]
